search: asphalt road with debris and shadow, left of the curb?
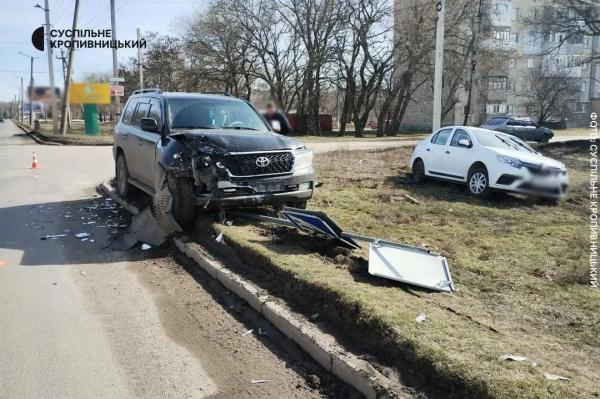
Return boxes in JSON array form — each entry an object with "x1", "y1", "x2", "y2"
[{"x1": 0, "y1": 122, "x2": 331, "y2": 399}]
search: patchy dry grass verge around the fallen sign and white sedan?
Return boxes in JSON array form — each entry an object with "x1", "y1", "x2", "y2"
[{"x1": 198, "y1": 143, "x2": 600, "y2": 398}]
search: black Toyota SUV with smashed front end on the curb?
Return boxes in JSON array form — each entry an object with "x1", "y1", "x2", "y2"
[{"x1": 113, "y1": 89, "x2": 314, "y2": 226}]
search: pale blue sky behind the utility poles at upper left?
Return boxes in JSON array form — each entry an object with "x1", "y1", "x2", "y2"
[{"x1": 0, "y1": 0, "x2": 207, "y2": 101}]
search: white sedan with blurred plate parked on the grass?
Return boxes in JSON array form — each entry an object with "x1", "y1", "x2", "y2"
[{"x1": 410, "y1": 126, "x2": 569, "y2": 199}]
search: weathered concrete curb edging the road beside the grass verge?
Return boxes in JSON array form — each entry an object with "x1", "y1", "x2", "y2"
[{"x1": 99, "y1": 181, "x2": 407, "y2": 399}]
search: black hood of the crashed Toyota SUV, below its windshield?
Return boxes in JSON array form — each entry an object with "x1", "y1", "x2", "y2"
[{"x1": 171, "y1": 130, "x2": 304, "y2": 152}]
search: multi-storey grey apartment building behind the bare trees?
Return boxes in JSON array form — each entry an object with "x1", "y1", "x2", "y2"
[{"x1": 402, "y1": 0, "x2": 600, "y2": 130}]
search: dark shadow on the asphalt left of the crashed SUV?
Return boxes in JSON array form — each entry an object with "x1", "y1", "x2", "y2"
[{"x1": 0, "y1": 196, "x2": 158, "y2": 266}]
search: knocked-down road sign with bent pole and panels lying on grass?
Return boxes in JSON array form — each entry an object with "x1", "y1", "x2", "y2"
[{"x1": 233, "y1": 207, "x2": 454, "y2": 292}]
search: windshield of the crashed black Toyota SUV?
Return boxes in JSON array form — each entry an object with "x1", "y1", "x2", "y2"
[{"x1": 167, "y1": 98, "x2": 268, "y2": 132}]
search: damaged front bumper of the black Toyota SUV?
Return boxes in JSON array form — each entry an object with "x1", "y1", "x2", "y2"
[{"x1": 195, "y1": 167, "x2": 314, "y2": 208}]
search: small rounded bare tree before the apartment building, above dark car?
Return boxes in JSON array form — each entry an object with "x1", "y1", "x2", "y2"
[{"x1": 519, "y1": 62, "x2": 581, "y2": 122}]
